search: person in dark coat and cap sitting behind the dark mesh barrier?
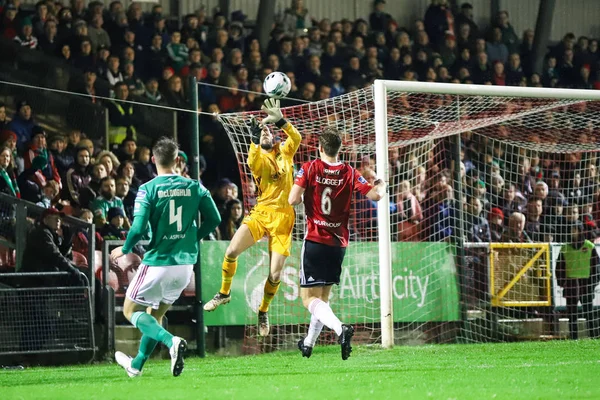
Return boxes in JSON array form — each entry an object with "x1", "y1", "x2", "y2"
[{"x1": 21, "y1": 208, "x2": 85, "y2": 286}]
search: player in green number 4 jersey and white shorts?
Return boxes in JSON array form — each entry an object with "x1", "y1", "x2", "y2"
[{"x1": 111, "y1": 138, "x2": 221, "y2": 378}]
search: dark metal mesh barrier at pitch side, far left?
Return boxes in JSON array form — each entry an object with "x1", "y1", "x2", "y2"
[{"x1": 0, "y1": 272, "x2": 96, "y2": 358}]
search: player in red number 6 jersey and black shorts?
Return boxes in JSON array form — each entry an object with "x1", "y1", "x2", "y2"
[{"x1": 289, "y1": 128, "x2": 385, "y2": 360}]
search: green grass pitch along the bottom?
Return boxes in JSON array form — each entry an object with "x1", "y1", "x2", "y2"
[{"x1": 0, "y1": 340, "x2": 600, "y2": 400}]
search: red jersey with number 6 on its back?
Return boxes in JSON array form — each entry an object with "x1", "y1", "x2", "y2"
[{"x1": 294, "y1": 159, "x2": 373, "y2": 247}]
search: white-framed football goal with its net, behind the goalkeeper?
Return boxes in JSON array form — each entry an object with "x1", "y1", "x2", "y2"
[{"x1": 217, "y1": 81, "x2": 600, "y2": 353}]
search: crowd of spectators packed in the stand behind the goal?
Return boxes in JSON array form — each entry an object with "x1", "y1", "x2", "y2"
[{"x1": 0, "y1": 0, "x2": 600, "y2": 260}]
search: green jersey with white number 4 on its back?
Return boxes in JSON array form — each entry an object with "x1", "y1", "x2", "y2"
[{"x1": 123, "y1": 175, "x2": 214, "y2": 266}]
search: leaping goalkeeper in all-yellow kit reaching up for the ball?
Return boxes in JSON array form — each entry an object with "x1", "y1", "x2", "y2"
[{"x1": 204, "y1": 99, "x2": 302, "y2": 336}]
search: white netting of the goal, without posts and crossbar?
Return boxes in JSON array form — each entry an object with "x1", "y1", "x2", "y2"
[{"x1": 219, "y1": 83, "x2": 600, "y2": 348}]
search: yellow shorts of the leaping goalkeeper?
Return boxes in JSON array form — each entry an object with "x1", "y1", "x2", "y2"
[{"x1": 243, "y1": 206, "x2": 296, "y2": 257}]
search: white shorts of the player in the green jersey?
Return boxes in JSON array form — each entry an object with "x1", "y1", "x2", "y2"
[{"x1": 126, "y1": 264, "x2": 194, "y2": 310}]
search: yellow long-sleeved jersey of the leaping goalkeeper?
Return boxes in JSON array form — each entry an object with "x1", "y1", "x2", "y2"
[{"x1": 248, "y1": 122, "x2": 302, "y2": 211}]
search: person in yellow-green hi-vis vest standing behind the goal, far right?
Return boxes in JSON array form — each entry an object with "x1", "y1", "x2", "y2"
[{"x1": 555, "y1": 221, "x2": 600, "y2": 339}]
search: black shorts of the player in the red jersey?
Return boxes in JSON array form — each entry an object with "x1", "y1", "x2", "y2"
[{"x1": 300, "y1": 240, "x2": 346, "y2": 287}]
